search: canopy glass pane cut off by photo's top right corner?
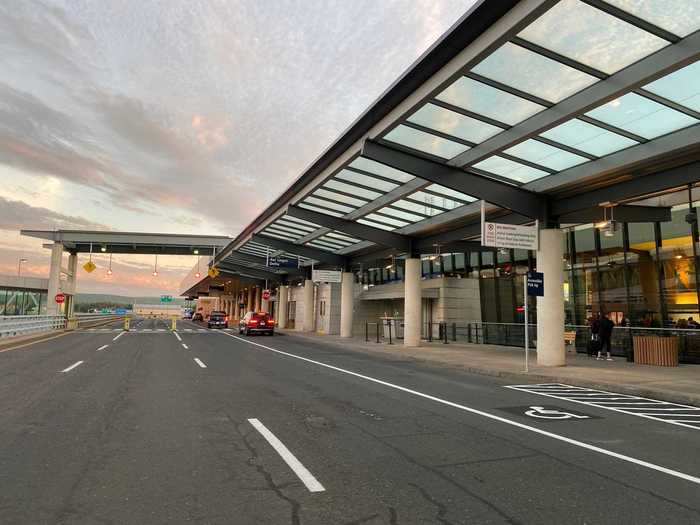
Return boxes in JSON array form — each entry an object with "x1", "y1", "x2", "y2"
[{"x1": 606, "y1": 0, "x2": 700, "y2": 36}]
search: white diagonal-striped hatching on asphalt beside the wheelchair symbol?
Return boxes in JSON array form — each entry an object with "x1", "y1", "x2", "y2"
[{"x1": 506, "y1": 383, "x2": 700, "y2": 430}]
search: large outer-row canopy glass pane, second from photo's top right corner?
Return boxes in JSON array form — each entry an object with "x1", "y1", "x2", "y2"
[{"x1": 518, "y1": 0, "x2": 669, "y2": 74}]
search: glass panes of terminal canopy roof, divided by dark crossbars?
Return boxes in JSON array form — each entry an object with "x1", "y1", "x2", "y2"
[{"x1": 237, "y1": 0, "x2": 700, "y2": 260}]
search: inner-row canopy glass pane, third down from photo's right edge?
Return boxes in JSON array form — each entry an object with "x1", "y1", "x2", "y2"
[{"x1": 542, "y1": 119, "x2": 638, "y2": 157}]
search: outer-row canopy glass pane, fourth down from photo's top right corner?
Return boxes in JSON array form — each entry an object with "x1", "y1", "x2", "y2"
[{"x1": 437, "y1": 77, "x2": 545, "y2": 126}]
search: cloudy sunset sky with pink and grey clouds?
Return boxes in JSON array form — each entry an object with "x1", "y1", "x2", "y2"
[{"x1": 0, "y1": 0, "x2": 474, "y2": 296}]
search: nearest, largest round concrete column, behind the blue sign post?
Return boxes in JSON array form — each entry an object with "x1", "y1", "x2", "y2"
[{"x1": 537, "y1": 229, "x2": 566, "y2": 366}]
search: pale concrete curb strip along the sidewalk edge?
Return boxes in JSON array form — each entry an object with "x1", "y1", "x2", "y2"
[{"x1": 282, "y1": 330, "x2": 700, "y2": 406}]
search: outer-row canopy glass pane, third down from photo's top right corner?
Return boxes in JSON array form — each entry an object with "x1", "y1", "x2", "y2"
[{"x1": 472, "y1": 42, "x2": 598, "y2": 102}]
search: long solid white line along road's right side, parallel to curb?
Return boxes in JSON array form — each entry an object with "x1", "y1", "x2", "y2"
[{"x1": 220, "y1": 332, "x2": 700, "y2": 485}]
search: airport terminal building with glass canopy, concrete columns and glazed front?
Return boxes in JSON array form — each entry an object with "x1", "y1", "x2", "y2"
[{"x1": 183, "y1": 0, "x2": 700, "y2": 365}]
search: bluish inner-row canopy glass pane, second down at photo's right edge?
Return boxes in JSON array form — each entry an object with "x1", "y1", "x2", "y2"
[{"x1": 586, "y1": 93, "x2": 698, "y2": 139}]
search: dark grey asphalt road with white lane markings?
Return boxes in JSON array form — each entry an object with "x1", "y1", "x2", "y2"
[{"x1": 0, "y1": 320, "x2": 700, "y2": 524}]
